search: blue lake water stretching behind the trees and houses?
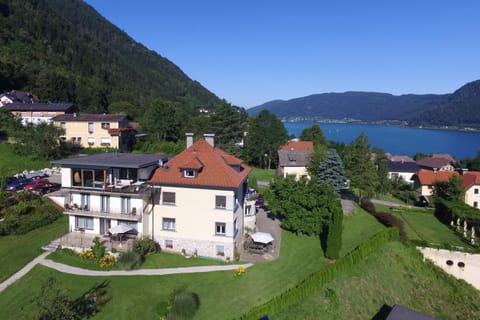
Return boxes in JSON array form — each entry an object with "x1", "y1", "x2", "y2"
[{"x1": 284, "y1": 121, "x2": 480, "y2": 160}]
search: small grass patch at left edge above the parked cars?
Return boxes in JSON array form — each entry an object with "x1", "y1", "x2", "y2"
[{"x1": 0, "y1": 143, "x2": 52, "y2": 176}]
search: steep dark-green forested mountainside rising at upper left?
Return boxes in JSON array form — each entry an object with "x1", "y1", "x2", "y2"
[{"x1": 0, "y1": 0, "x2": 220, "y2": 119}]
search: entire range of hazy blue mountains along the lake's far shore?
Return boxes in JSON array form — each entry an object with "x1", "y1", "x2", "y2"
[{"x1": 247, "y1": 80, "x2": 480, "y2": 128}]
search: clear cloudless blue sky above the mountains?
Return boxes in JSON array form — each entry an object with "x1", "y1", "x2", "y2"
[{"x1": 86, "y1": 0, "x2": 480, "y2": 108}]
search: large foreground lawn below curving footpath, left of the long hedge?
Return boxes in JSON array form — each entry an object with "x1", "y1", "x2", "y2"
[{"x1": 0, "y1": 231, "x2": 326, "y2": 319}]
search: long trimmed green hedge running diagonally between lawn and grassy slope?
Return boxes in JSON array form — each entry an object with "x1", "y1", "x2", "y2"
[{"x1": 240, "y1": 228, "x2": 399, "y2": 319}]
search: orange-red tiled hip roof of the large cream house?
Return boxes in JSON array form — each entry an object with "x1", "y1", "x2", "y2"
[{"x1": 149, "y1": 139, "x2": 251, "y2": 189}]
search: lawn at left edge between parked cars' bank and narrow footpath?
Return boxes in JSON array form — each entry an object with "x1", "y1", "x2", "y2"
[{"x1": 0, "y1": 215, "x2": 68, "y2": 282}]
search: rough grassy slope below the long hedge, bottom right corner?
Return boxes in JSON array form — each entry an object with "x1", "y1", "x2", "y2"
[{"x1": 271, "y1": 242, "x2": 480, "y2": 320}]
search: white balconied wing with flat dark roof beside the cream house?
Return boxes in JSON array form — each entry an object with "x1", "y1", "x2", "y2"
[{"x1": 49, "y1": 152, "x2": 167, "y2": 236}]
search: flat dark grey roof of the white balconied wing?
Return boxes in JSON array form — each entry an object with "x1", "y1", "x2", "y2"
[{"x1": 52, "y1": 152, "x2": 168, "y2": 169}]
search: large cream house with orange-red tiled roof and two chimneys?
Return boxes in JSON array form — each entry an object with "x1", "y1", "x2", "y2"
[{"x1": 149, "y1": 133, "x2": 251, "y2": 258}]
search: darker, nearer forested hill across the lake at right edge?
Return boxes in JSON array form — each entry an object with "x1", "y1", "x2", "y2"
[{"x1": 410, "y1": 80, "x2": 480, "y2": 128}]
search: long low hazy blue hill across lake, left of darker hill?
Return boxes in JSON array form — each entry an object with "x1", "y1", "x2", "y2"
[{"x1": 248, "y1": 91, "x2": 448, "y2": 122}]
